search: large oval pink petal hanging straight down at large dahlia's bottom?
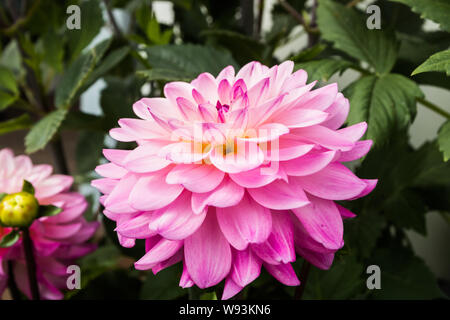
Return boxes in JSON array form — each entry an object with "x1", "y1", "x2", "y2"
[{"x1": 184, "y1": 211, "x2": 231, "y2": 289}]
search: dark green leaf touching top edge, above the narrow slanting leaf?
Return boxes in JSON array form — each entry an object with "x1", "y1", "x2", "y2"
[{"x1": 65, "y1": 0, "x2": 103, "y2": 58}]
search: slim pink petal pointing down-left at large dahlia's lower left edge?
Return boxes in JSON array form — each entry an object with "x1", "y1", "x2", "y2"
[{"x1": 134, "y1": 239, "x2": 183, "y2": 270}]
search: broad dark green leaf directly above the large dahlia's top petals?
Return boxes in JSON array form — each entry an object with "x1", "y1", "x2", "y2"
[{"x1": 147, "y1": 44, "x2": 237, "y2": 75}]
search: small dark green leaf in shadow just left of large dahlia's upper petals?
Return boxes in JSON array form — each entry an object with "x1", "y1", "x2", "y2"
[{"x1": 75, "y1": 131, "x2": 105, "y2": 173}]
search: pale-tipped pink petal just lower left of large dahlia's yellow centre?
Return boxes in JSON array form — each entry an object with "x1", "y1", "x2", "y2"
[{"x1": 166, "y1": 164, "x2": 225, "y2": 193}]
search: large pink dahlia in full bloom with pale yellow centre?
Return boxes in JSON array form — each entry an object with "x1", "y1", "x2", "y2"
[{"x1": 92, "y1": 61, "x2": 376, "y2": 299}]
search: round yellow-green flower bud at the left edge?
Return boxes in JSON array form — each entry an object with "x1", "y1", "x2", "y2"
[{"x1": 0, "y1": 191, "x2": 39, "y2": 227}]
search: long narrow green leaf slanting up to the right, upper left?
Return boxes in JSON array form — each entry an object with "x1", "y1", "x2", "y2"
[{"x1": 55, "y1": 40, "x2": 110, "y2": 109}]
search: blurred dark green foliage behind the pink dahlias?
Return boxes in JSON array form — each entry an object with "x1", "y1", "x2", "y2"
[{"x1": 0, "y1": 0, "x2": 450, "y2": 299}]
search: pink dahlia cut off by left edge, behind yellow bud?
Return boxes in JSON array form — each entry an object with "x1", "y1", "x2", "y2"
[{"x1": 0, "y1": 149, "x2": 98, "y2": 300}]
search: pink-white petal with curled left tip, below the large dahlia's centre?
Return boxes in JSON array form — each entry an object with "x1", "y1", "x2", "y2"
[{"x1": 191, "y1": 177, "x2": 245, "y2": 214}]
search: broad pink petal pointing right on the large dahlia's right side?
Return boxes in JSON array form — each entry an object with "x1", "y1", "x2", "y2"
[{"x1": 293, "y1": 162, "x2": 367, "y2": 200}]
